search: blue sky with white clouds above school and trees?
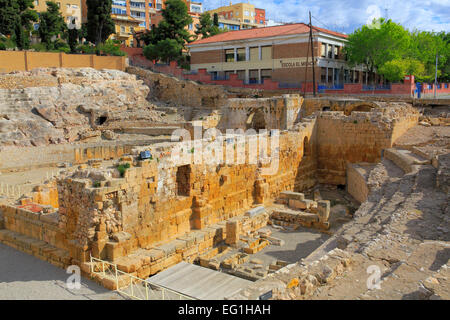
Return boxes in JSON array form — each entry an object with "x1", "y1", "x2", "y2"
[{"x1": 199, "y1": 0, "x2": 450, "y2": 33}]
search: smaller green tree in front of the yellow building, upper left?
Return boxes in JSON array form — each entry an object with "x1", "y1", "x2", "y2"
[{"x1": 39, "y1": 1, "x2": 67, "y2": 50}]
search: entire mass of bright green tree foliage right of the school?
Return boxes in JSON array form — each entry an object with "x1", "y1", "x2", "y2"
[{"x1": 345, "y1": 18, "x2": 450, "y2": 81}]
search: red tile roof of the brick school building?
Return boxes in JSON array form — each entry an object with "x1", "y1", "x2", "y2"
[{"x1": 189, "y1": 23, "x2": 348, "y2": 45}]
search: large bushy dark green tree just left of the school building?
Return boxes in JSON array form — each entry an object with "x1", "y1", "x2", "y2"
[{"x1": 142, "y1": 0, "x2": 194, "y2": 62}]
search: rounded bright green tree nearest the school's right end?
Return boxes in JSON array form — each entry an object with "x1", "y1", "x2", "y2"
[{"x1": 345, "y1": 18, "x2": 410, "y2": 83}]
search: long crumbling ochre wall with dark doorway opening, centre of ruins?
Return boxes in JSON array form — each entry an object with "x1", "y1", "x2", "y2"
[{"x1": 58, "y1": 122, "x2": 316, "y2": 257}]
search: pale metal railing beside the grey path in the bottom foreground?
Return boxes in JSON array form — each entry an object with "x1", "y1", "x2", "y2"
[{"x1": 91, "y1": 256, "x2": 197, "y2": 300}]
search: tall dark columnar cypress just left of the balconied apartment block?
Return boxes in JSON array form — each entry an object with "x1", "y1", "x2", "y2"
[{"x1": 86, "y1": 0, "x2": 115, "y2": 46}]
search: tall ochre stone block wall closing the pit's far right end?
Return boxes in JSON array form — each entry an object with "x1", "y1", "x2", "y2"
[{"x1": 317, "y1": 105, "x2": 419, "y2": 185}]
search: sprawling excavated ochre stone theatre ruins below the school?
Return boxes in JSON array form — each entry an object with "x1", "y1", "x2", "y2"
[{"x1": 0, "y1": 67, "x2": 450, "y2": 299}]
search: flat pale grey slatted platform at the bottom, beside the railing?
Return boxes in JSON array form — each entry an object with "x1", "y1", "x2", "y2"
[{"x1": 147, "y1": 262, "x2": 253, "y2": 300}]
